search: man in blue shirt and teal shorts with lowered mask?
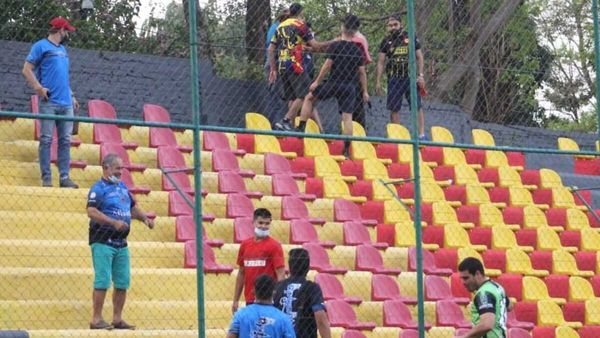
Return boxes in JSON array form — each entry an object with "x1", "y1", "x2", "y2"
[{"x1": 87, "y1": 154, "x2": 154, "y2": 330}]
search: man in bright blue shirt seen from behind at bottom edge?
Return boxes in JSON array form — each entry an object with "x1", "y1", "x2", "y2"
[{"x1": 227, "y1": 274, "x2": 296, "y2": 338}]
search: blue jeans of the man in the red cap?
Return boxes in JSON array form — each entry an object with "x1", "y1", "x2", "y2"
[{"x1": 39, "y1": 101, "x2": 73, "y2": 180}]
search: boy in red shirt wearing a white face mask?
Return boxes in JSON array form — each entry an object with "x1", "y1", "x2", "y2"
[{"x1": 231, "y1": 208, "x2": 285, "y2": 313}]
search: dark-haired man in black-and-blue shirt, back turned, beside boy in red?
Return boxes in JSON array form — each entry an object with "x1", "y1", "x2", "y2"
[{"x1": 274, "y1": 248, "x2": 331, "y2": 338}]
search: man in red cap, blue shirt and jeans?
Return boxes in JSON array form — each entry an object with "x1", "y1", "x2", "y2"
[{"x1": 23, "y1": 17, "x2": 79, "y2": 188}]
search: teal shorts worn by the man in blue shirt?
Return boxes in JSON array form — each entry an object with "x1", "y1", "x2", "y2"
[{"x1": 92, "y1": 243, "x2": 131, "y2": 290}]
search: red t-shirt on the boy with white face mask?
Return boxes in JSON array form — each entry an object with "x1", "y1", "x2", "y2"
[{"x1": 237, "y1": 237, "x2": 285, "y2": 302}]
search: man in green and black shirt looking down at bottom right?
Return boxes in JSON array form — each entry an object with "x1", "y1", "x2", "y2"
[{"x1": 458, "y1": 257, "x2": 512, "y2": 338}]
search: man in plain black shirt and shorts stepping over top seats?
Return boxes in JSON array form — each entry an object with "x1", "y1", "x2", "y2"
[{"x1": 298, "y1": 14, "x2": 369, "y2": 157}]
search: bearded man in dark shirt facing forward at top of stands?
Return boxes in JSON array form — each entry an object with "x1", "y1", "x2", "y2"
[{"x1": 375, "y1": 15, "x2": 426, "y2": 140}]
